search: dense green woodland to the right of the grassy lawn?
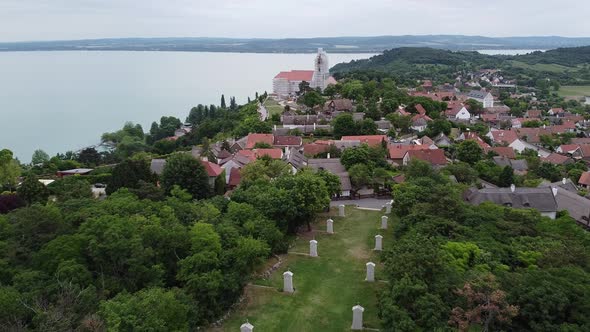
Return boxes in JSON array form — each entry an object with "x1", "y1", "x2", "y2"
[{"x1": 379, "y1": 162, "x2": 590, "y2": 331}]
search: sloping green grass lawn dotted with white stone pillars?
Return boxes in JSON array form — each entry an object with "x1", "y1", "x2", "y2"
[{"x1": 216, "y1": 207, "x2": 388, "y2": 332}]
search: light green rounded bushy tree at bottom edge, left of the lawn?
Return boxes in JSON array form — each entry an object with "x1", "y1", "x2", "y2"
[{"x1": 99, "y1": 288, "x2": 190, "y2": 332}]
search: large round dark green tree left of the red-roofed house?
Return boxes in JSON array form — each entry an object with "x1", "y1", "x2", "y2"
[{"x1": 161, "y1": 153, "x2": 211, "y2": 199}]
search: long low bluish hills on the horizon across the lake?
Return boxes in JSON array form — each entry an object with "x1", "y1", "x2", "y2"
[{"x1": 0, "y1": 35, "x2": 590, "y2": 53}]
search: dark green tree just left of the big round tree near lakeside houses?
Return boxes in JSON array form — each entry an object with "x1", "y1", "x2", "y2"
[{"x1": 106, "y1": 159, "x2": 155, "y2": 195}]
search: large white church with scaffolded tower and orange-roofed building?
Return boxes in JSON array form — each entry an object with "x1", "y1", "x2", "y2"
[{"x1": 272, "y1": 48, "x2": 336, "y2": 98}]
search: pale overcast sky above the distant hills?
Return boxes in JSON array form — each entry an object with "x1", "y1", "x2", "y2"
[{"x1": 0, "y1": 0, "x2": 590, "y2": 41}]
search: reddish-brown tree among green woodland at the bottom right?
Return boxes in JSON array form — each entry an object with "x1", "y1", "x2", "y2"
[{"x1": 449, "y1": 274, "x2": 518, "y2": 332}]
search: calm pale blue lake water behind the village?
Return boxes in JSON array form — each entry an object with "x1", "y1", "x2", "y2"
[{"x1": 0, "y1": 52, "x2": 371, "y2": 162}]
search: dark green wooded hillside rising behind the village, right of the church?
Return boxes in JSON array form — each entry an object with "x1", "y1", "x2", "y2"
[{"x1": 330, "y1": 46, "x2": 590, "y2": 85}]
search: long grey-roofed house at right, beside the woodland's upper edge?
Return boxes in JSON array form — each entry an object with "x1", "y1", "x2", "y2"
[{"x1": 464, "y1": 185, "x2": 558, "y2": 219}]
